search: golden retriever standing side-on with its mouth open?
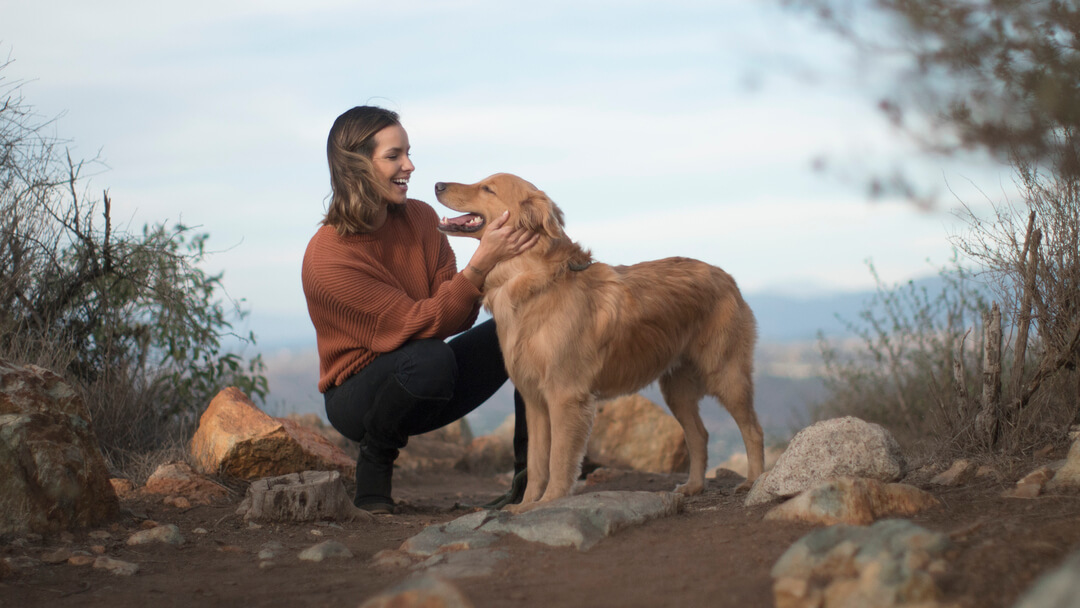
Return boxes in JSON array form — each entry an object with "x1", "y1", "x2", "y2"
[{"x1": 435, "y1": 173, "x2": 764, "y2": 512}]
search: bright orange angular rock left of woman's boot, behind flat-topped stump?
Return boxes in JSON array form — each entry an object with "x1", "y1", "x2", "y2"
[{"x1": 190, "y1": 387, "x2": 356, "y2": 479}]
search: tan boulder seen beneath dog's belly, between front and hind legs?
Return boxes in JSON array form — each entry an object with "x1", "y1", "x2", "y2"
[{"x1": 586, "y1": 394, "x2": 690, "y2": 473}]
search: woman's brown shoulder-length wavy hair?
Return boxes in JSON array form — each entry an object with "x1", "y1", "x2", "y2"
[{"x1": 323, "y1": 106, "x2": 401, "y2": 234}]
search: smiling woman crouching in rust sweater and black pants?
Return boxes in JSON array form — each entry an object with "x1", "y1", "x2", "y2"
[{"x1": 301, "y1": 106, "x2": 537, "y2": 513}]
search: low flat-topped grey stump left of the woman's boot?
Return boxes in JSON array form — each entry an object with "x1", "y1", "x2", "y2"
[{"x1": 237, "y1": 471, "x2": 373, "y2": 522}]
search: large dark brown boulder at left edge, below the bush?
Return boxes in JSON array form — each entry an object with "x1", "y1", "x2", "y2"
[{"x1": 0, "y1": 361, "x2": 119, "y2": 533}]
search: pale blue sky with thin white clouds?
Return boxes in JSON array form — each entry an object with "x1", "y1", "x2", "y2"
[{"x1": 0, "y1": 0, "x2": 1011, "y2": 346}]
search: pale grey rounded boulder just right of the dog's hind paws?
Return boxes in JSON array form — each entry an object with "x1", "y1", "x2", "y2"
[{"x1": 745, "y1": 416, "x2": 906, "y2": 506}]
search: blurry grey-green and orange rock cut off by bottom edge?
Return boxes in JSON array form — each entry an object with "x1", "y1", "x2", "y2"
[{"x1": 771, "y1": 519, "x2": 951, "y2": 608}]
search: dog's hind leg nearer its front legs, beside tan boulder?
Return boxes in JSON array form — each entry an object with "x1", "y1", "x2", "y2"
[{"x1": 660, "y1": 365, "x2": 708, "y2": 496}]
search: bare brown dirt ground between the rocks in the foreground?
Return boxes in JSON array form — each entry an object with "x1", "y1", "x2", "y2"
[{"x1": 0, "y1": 462, "x2": 1080, "y2": 608}]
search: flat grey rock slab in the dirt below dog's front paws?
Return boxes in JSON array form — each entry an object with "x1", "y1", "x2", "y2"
[{"x1": 402, "y1": 491, "x2": 683, "y2": 557}]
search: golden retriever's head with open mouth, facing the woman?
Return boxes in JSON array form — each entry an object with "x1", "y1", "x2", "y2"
[{"x1": 435, "y1": 173, "x2": 564, "y2": 239}]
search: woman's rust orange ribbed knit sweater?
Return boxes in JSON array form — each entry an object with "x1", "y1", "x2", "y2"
[{"x1": 300, "y1": 199, "x2": 481, "y2": 392}]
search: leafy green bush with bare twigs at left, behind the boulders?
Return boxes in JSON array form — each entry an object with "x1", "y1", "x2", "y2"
[{"x1": 0, "y1": 66, "x2": 268, "y2": 481}]
